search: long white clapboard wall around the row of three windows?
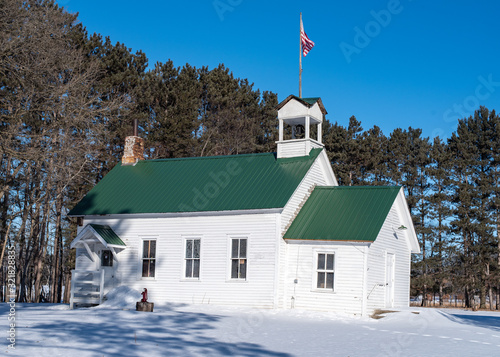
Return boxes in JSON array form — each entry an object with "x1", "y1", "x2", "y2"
[{"x1": 80, "y1": 213, "x2": 279, "y2": 308}]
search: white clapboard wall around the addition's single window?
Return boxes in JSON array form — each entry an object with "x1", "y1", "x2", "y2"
[{"x1": 284, "y1": 241, "x2": 365, "y2": 315}]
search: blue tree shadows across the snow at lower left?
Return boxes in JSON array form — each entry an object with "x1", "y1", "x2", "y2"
[{"x1": 0, "y1": 304, "x2": 290, "y2": 357}]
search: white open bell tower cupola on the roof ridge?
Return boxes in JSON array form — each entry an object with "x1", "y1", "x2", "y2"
[{"x1": 276, "y1": 95, "x2": 327, "y2": 158}]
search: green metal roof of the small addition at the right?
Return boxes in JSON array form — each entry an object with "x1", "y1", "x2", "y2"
[{"x1": 284, "y1": 186, "x2": 401, "y2": 242}]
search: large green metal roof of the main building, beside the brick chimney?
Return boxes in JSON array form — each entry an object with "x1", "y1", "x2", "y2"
[{"x1": 68, "y1": 149, "x2": 322, "y2": 216}]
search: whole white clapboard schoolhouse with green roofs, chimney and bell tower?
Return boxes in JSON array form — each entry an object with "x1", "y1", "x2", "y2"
[{"x1": 69, "y1": 95, "x2": 420, "y2": 315}]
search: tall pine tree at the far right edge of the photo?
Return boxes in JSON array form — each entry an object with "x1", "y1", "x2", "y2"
[{"x1": 449, "y1": 107, "x2": 498, "y2": 308}]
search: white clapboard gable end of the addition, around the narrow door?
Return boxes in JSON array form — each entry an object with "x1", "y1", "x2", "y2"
[{"x1": 367, "y1": 201, "x2": 411, "y2": 313}]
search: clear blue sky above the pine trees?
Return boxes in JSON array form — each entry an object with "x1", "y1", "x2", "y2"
[{"x1": 58, "y1": 0, "x2": 500, "y2": 138}]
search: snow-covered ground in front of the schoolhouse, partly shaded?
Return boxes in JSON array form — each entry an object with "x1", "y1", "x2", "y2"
[{"x1": 0, "y1": 290, "x2": 500, "y2": 357}]
